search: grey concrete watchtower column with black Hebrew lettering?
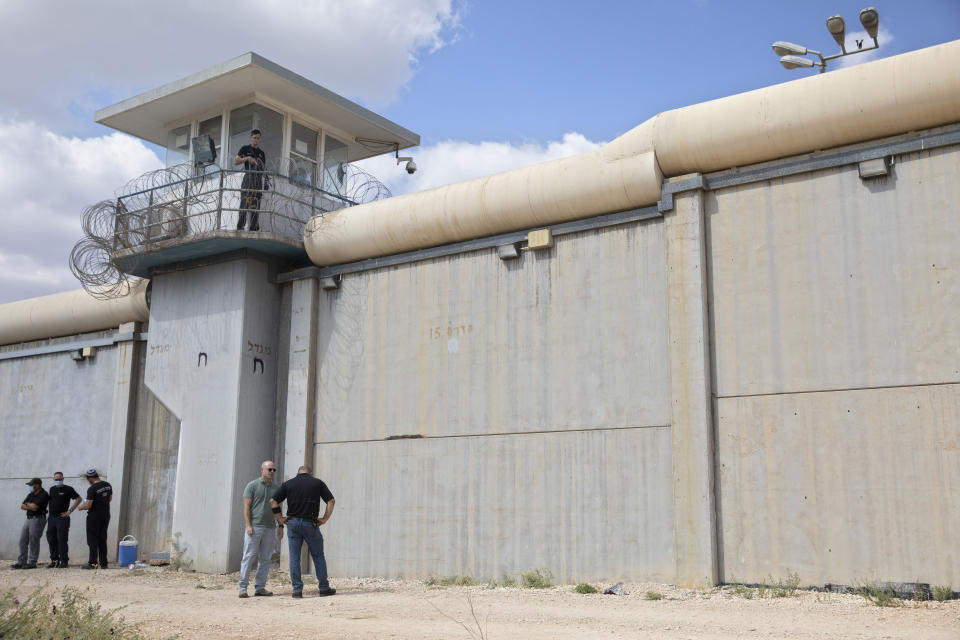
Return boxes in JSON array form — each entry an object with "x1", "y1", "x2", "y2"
[{"x1": 144, "y1": 258, "x2": 280, "y2": 573}]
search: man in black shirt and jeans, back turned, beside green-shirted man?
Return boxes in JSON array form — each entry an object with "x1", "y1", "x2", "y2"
[{"x1": 270, "y1": 465, "x2": 337, "y2": 598}]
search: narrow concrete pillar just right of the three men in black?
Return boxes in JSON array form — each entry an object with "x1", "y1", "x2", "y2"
[{"x1": 108, "y1": 322, "x2": 139, "y2": 560}]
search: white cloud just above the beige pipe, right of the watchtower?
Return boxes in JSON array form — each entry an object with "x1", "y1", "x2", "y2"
[{"x1": 358, "y1": 133, "x2": 603, "y2": 195}]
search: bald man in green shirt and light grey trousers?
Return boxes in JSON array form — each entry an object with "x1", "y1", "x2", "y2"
[{"x1": 239, "y1": 460, "x2": 283, "y2": 598}]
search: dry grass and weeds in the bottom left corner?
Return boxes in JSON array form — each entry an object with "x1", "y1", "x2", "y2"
[{"x1": 0, "y1": 586, "x2": 144, "y2": 640}]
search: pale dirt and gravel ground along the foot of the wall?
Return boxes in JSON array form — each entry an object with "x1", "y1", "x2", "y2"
[{"x1": 0, "y1": 562, "x2": 960, "y2": 640}]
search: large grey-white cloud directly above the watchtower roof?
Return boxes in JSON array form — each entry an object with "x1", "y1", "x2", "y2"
[{"x1": 0, "y1": 0, "x2": 459, "y2": 130}]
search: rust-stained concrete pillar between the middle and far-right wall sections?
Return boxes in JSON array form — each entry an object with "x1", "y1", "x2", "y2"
[{"x1": 664, "y1": 178, "x2": 717, "y2": 588}]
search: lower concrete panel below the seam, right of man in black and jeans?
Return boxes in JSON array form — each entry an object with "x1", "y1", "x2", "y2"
[{"x1": 315, "y1": 428, "x2": 674, "y2": 582}]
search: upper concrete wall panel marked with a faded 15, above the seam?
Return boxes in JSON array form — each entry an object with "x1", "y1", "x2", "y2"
[{"x1": 315, "y1": 221, "x2": 669, "y2": 442}]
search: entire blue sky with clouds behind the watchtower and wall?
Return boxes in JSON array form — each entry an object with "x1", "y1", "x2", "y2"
[{"x1": 0, "y1": 0, "x2": 960, "y2": 304}]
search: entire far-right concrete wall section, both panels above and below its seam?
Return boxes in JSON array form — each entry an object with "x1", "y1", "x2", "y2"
[{"x1": 705, "y1": 147, "x2": 960, "y2": 584}]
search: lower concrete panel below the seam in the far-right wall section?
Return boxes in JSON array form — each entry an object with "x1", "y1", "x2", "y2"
[{"x1": 718, "y1": 384, "x2": 960, "y2": 585}]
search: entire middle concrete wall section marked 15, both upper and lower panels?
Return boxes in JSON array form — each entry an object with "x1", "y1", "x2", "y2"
[{"x1": 314, "y1": 221, "x2": 674, "y2": 580}]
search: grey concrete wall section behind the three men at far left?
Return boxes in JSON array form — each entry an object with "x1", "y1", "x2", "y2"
[{"x1": 0, "y1": 333, "x2": 117, "y2": 563}]
